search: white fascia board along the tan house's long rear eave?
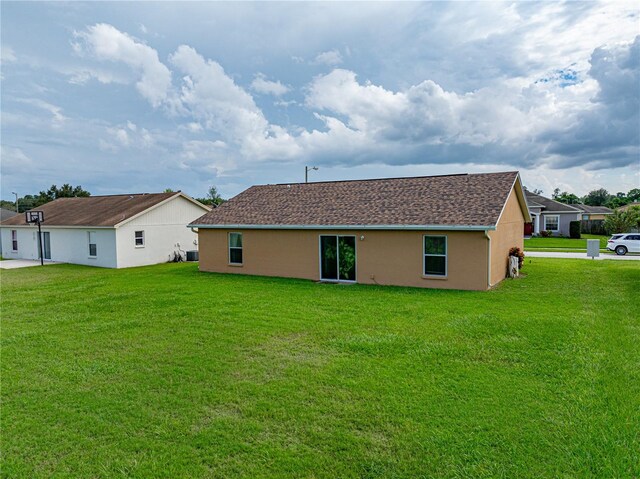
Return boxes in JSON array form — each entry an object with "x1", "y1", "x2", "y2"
[{"x1": 187, "y1": 224, "x2": 496, "y2": 231}]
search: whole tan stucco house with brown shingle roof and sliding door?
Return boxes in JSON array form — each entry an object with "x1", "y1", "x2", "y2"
[{"x1": 190, "y1": 172, "x2": 530, "y2": 290}]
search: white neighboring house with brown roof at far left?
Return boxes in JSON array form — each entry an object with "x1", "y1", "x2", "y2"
[{"x1": 0, "y1": 192, "x2": 210, "y2": 268}]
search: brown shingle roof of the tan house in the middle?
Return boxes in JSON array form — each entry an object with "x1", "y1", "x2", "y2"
[{"x1": 193, "y1": 171, "x2": 518, "y2": 226}]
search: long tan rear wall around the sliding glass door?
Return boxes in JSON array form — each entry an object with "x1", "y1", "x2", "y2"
[{"x1": 199, "y1": 230, "x2": 490, "y2": 290}]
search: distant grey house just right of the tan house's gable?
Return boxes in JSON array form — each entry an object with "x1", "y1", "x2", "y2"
[{"x1": 525, "y1": 191, "x2": 582, "y2": 236}]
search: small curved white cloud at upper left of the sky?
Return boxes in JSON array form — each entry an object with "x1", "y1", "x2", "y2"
[{"x1": 74, "y1": 23, "x2": 171, "y2": 107}]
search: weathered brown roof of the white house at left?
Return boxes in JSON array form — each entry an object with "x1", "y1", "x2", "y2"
[{"x1": 0, "y1": 193, "x2": 180, "y2": 226}]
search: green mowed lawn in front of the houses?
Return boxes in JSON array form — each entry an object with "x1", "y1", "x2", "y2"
[{"x1": 1, "y1": 258, "x2": 640, "y2": 478}]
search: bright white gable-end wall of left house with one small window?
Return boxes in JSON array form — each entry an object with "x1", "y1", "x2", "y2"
[{"x1": 116, "y1": 197, "x2": 207, "y2": 268}]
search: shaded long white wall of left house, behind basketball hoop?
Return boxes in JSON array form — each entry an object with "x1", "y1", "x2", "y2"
[{"x1": 0, "y1": 225, "x2": 116, "y2": 268}]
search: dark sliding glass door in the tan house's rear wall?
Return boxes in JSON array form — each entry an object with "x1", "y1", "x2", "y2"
[{"x1": 320, "y1": 235, "x2": 356, "y2": 281}]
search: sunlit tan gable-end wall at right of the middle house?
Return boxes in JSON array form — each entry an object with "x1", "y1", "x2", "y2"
[{"x1": 489, "y1": 190, "x2": 524, "y2": 286}]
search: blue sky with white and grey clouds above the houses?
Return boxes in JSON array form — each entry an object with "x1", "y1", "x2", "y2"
[{"x1": 0, "y1": 1, "x2": 640, "y2": 199}]
